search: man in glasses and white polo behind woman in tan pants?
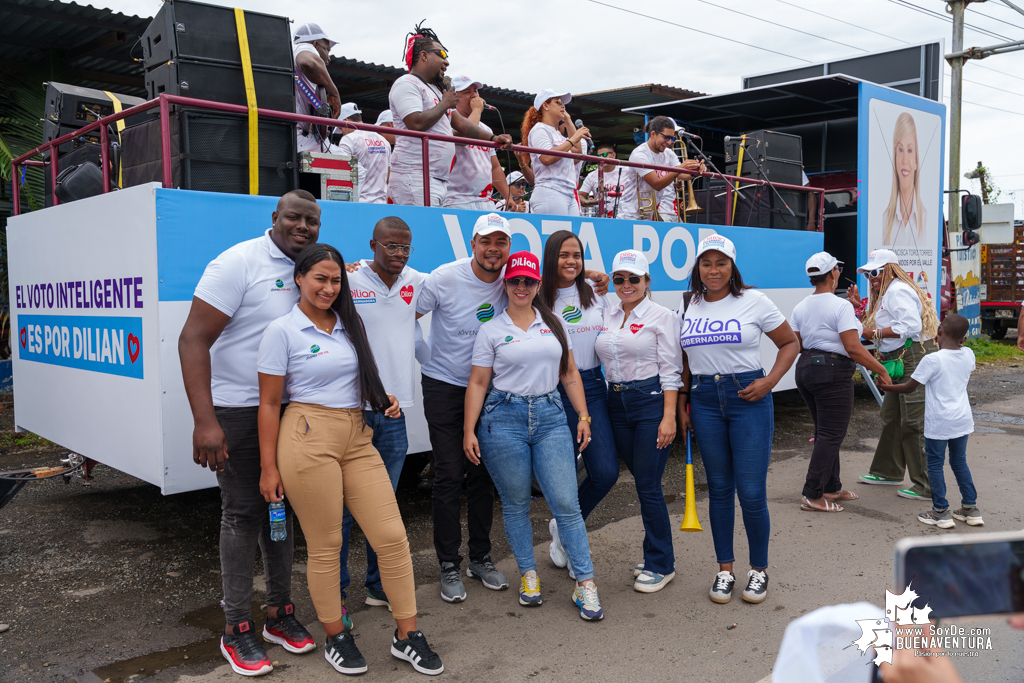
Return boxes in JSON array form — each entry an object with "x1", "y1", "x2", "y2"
[{"x1": 341, "y1": 216, "x2": 427, "y2": 606}]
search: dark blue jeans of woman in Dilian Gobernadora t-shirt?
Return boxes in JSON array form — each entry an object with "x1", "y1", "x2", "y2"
[{"x1": 690, "y1": 370, "x2": 775, "y2": 569}]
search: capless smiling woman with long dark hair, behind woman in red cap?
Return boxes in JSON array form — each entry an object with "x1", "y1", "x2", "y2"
[{"x1": 540, "y1": 230, "x2": 618, "y2": 577}]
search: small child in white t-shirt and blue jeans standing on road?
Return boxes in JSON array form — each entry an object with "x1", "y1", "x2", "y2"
[{"x1": 880, "y1": 313, "x2": 984, "y2": 528}]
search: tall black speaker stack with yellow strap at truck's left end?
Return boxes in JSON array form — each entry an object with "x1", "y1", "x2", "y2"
[{"x1": 124, "y1": 0, "x2": 298, "y2": 196}]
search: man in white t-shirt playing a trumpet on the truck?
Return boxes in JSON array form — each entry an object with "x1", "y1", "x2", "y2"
[{"x1": 618, "y1": 116, "x2": 705, "y2": 220}]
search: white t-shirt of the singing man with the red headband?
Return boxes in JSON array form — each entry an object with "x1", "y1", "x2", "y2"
[{"x1": 388, "y1": 74, "x2": 455, "y2": 180}]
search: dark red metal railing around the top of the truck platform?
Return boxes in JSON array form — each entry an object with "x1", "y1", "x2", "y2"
[{"x1": 11, "y1": 93, "x2": 825, "y2": 231}]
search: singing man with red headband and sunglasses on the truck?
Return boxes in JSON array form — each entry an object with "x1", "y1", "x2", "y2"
[{"x1": 388, "y1": 26, "x2": 512, "y2": 207}]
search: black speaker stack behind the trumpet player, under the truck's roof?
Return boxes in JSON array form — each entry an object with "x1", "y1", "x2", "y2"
[{"x1": 725, "y1": 130, "x2": 807, "y2": 230}]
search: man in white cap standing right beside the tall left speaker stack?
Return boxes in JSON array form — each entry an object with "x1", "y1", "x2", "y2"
[{"x1": 292, "y1": 23, "x2": 341, "y2": 154}]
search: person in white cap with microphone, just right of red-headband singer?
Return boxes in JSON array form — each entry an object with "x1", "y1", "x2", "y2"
[{"x1": 444, "y1": 76, "x2": 509, "y2": 211}]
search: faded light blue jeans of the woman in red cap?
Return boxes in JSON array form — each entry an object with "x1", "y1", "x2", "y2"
[{"x1": 476, "y1": 389, "x2": 594, "y2": 582}]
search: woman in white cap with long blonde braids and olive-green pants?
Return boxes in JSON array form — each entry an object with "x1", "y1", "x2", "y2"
[{"x1": 857, "y1": 249, "x2": 939, "y2": 501}]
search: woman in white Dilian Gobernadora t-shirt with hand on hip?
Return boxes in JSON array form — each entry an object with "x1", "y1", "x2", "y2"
[{"x1": 677, "y1": 234, "x2": 800, "y2": 603}]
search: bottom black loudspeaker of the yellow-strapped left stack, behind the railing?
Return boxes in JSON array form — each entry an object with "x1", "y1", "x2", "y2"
[{"x1": 123, "y1": 110, "x2": 298, "y2": 197}]
